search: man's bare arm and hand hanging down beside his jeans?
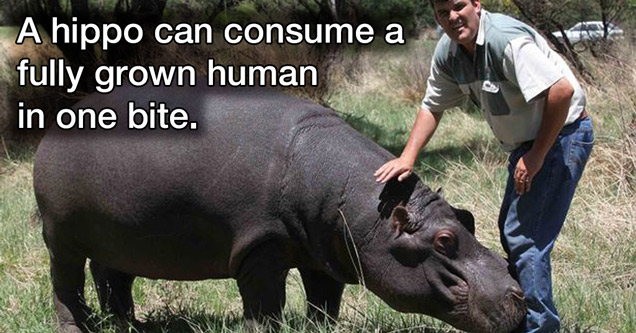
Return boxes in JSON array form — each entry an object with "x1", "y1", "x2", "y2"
[{"x1": 514, "y1": 77, "x2": 574, "y2": 195}]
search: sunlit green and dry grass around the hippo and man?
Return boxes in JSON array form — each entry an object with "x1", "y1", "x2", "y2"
[{"x1": 0, "y1": 26, "x2": 636, "y2": 332}]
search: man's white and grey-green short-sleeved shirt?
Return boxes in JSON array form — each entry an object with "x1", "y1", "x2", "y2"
[{"x1": 422, "y1": 9, "x2": 585, "y2": 151}]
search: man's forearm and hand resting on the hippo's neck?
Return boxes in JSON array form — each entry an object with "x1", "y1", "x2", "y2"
[{"x1": 373, "y1": 107, "x2": 443, "y2": 183}]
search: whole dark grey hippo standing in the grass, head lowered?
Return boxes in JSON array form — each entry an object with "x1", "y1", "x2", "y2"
[{"x1": 34, "y1": 84, "x2": 525, "y2": 332}]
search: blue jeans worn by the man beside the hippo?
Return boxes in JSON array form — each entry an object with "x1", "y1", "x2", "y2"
[{"x1": 499, "y1": 118, "x2": 594, "y2": 332}]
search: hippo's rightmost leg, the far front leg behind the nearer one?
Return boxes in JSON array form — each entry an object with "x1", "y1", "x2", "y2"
[{"x1": 298, "y1": 268, "x2": 344, "y2": 323}]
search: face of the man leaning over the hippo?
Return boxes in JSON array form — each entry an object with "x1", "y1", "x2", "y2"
[{"x1": 433, "y1": 0, "x2": 481, "y2": 52}]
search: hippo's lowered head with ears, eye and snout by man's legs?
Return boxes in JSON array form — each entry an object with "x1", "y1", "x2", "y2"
[{"x1": 362, "y1": 177, "x2": 526, "y2": 332}]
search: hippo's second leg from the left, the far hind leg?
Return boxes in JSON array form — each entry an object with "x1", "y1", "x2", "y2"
[{"x1": 90, "y1": 260, "x2": 135, "y2": 326}]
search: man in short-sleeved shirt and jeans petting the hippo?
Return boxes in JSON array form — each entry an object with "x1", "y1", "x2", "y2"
[{"x1": 375, "y1": 0, "x2": 594, "y2": 332}]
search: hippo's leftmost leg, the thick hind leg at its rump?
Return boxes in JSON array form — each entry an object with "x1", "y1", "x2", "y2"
[{"x1": 49, "y1": 251, "x2": 92, "y2": 333}]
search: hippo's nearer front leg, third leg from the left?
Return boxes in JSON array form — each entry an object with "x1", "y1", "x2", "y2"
[{"x1": 237, "y1": 242, "x2": 289, "y2": 331}]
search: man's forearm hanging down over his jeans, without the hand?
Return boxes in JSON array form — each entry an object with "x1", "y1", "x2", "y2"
[{"x1": 530, "y1": 78, "x2": 574, "y2": 160}]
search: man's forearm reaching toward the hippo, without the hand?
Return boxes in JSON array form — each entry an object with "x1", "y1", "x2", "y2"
[{"x1": 400, "y1": 107, "x2": 442, "y2": 163}]
